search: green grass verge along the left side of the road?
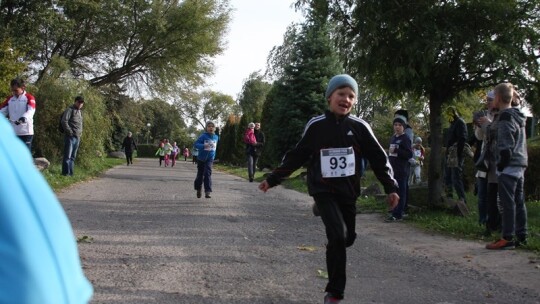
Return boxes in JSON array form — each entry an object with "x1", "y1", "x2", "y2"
[{"x1": 42, "y1": 158, "x2": 125, "y2": 192}]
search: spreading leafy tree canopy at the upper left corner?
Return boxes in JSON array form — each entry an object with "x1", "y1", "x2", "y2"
[{"x1": 0, "y1": 0, "x2": 230, "y2": 96}]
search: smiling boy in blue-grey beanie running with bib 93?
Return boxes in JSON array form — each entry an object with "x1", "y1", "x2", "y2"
[{"x1": 259, "y1": 74, "x2": 399, "y2": 303}]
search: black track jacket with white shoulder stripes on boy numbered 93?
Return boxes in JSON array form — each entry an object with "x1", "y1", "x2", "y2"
[{"x1": 266, "y1": 111, "x2": 398, "y2": 199}]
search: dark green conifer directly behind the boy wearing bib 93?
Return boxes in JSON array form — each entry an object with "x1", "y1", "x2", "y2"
[{"x1": 263, "y1": 23, "x2": 341, "y2": 164}]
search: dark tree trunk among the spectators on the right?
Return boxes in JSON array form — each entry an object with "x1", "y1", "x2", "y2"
[{"x1": 428, "y1": 96, "x2": 444, "y2": 206}]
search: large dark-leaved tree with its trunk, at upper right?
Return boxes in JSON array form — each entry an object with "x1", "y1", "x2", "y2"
[{"x1": 298, "y1": 0, "x2": 540, "y2": 203}]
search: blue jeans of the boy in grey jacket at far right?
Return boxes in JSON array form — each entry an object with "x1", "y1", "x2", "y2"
[{"x1": 497, "y1": 173, "x2": 527, "y2": 240}]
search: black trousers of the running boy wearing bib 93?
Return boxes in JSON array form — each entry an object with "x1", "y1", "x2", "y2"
[{"x1": 313, "y1": 193, "x2": 356, "y2": 298}]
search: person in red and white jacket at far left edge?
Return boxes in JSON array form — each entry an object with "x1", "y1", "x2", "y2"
[{"x1": 0, "y1": 78, "x2": 36, "y2": 151}]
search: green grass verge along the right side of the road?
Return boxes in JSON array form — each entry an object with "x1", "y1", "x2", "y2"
[{"x1": 216, "y1": 164, "x2": 540, "y2": 255}]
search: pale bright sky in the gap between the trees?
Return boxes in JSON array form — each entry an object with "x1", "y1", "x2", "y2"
[{"x1": 207, "y1": 0, "x2": 302, "y2": 99}]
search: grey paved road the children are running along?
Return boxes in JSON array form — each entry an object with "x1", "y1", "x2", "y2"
[{"x1": 59, "y1": 159, "x2": 540, "y2": 304}]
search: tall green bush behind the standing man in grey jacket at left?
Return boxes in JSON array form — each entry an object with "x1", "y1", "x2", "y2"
[{"x1": 34, "y1": 58, "x2": 110, "y2": 167}]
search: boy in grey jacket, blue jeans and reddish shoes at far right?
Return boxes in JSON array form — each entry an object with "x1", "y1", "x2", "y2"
[{"x1": 486, "y1": 83, "x2": 528, "y2": 249}]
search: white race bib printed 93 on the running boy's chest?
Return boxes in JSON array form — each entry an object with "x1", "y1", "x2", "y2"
[{"x1": 321, "y1": 147, "x2": 356, "y2": 178}]
